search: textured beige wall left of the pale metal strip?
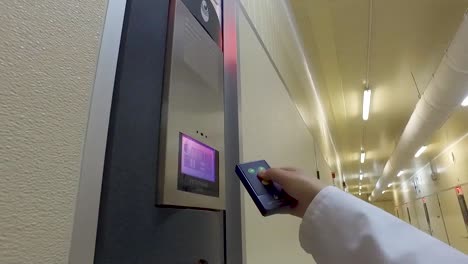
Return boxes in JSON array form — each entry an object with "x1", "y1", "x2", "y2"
[{"x1": 0, "y1": 0, "x2": 106, "y2": 263}]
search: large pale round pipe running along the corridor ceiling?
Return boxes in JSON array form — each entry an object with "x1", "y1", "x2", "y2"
[{"x1": 370, "y1": 13, "x2": 468, "y2": 201}]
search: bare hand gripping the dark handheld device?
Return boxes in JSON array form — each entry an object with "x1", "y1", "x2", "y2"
[{"x1": 258, "y1": 168, "x2": 326, "y2": 218}]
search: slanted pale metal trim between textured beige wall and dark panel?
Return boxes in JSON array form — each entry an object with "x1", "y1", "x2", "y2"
[{"x1": 68, "y1": 0, "x2": 127, "y2": 264}]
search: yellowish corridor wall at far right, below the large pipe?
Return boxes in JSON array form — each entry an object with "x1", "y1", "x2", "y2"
[{"x1": 393, "y1": 110, "x2": 468, "y2": 253}]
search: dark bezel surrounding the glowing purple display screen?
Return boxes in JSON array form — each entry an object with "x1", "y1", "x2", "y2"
[{"x1": 177, "y1": 132, "x2": 219, "y2": 197}]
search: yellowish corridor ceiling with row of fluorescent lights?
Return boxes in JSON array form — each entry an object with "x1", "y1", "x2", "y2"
[{"x1": 290, "y1": 0, "x2": 468, "y2": 198}]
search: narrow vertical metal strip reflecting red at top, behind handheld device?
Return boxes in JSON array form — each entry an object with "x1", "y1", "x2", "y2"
[{"x1": 223, "y1": 0, "x2": 246, "y2": 264}]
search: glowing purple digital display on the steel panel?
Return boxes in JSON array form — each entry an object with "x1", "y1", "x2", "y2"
[{"x1": 180, "y1": 134, "x2": 217, "y2": 182}]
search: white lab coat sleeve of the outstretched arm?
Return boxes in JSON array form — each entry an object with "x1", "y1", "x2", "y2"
[{"x1": 299, "y1": 187, "x2": 468, "y2": 264}]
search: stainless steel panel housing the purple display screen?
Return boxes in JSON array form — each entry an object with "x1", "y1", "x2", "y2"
[{"x1": 157, "y1": 0, "x2": 225, "y2": 210}]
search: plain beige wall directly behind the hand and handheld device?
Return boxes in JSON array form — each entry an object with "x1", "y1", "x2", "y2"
[{"x1": 239, "y1": 8, "x2": 332, "y2": 264}]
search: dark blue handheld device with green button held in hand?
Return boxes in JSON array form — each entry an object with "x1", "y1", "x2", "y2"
[{"x1": 236, "y1": 160, "x2": 297, "y2": 216}]
